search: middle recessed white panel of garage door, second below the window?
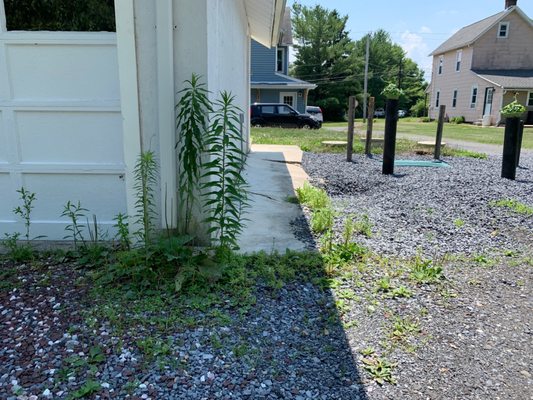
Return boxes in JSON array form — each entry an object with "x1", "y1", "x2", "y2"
[{"x1": 16, "y1": 111, "x2": 123, "y2": 165}]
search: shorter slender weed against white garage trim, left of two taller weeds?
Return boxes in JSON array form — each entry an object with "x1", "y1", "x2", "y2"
[{"x1": 133, "y1": 151, "x2": 158, "y2": 249}]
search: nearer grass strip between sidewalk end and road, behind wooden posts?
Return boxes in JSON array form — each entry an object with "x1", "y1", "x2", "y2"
[{"x1": 252, "y1": 128, "x2": 484, "y2": 158}]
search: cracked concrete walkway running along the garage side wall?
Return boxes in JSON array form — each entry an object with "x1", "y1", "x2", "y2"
[{"x1": 239, "y1": 145, "x2": 308, "y2": 253}]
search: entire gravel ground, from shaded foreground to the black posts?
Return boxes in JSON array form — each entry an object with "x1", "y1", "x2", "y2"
[{"x1": 0, "y1": 154, "x2": 533, "y2": 400}]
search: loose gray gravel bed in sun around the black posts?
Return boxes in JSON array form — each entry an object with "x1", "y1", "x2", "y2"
[{"x1": 303, "y1": 153, "x2": 533, "y2": 256}]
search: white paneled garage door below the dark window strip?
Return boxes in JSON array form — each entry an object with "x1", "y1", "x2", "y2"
[{"x1": 0, "y1": 30, "x2": 126, "y2": 240}]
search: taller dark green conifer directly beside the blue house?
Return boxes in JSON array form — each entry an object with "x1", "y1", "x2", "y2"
[{"x1": 292, "y1": 3, "x2": 363, "y2": 120}]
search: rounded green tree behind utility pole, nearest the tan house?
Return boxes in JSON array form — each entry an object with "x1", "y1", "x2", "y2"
[{"x1": 355, "y1": 29, "x2": 427, "y2": 109}]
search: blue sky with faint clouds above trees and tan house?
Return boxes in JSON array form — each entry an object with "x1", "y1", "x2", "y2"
[{"x1": 287, "y1": 0, "x2": 533, "y2": 79}]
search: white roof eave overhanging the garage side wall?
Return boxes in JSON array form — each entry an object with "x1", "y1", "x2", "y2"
[{"x1": 244, "y1": 0, "x2": 287, "y2": 48}]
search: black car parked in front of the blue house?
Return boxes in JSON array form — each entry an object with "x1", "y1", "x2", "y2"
[{"x1": 250, "y1": 103, "x2": 322, "y2": 129}]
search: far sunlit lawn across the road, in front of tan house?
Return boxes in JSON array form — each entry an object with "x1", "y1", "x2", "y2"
[{"x1": 324, "y1": 118, "x2": 533, "y2": 149}]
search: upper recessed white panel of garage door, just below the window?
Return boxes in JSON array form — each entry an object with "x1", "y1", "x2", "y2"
[{"x1": 6, "y1": 43, "x2": 120, "y2": 100}]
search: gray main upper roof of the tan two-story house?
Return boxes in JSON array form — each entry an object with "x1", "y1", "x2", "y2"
[{"x1": 430, "y1": 6, "x2": 533, "y2": 56}]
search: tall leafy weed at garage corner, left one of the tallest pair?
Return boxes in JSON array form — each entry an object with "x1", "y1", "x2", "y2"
[{"x1": 172, "y1": 74, "x2": 212, "y2": 233}]
